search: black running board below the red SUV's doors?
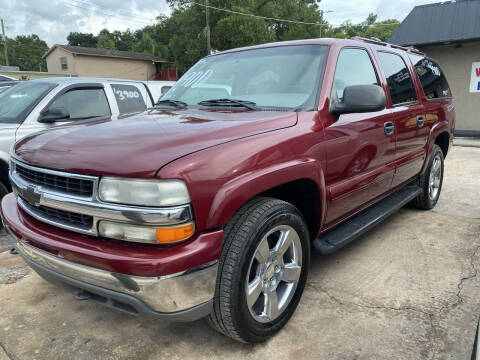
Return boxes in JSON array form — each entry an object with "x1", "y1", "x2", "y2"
[{"x1": 313, "y1": 183, "x2": 422, "y2": 255}]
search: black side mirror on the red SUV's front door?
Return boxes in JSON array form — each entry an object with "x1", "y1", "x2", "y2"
[{"x1": 330, "y1": 85, "x2": 387, "y2": 115}]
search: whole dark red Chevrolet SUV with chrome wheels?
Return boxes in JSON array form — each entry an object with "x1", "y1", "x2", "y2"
[{"x1": 1, "y1": 38, "x2": 455, "y2": 343}]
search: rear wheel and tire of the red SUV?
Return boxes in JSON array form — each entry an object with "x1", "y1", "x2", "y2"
[{"x1": 411, "y1": 144, "x2": 444, "y2": 210}]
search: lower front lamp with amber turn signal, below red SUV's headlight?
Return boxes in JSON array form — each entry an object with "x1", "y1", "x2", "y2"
[{"x1": 98, "y1": 221, "x2": 195, "y2": 244}]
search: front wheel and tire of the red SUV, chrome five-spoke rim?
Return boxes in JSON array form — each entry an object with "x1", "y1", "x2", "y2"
[{"x1": 208, "y1": 198, "x2": 310, "y2": 343}]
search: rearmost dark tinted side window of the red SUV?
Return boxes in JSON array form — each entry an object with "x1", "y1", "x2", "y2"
[{"x1": 408, "y1": 54, "x2": 452, "y2": 99}]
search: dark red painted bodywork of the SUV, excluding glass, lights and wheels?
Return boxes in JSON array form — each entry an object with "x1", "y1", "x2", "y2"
[{"x1": 2, "y1": 39, "x2": 455, "y2": 276}]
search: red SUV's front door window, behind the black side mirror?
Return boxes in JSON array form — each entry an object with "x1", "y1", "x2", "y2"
[{"x1": 333, "y1": 48, "x2": 378, "y2": 100}]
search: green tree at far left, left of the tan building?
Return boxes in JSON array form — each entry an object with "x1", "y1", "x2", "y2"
[{"x1": 0, "y1": 34, "x2": 48, "y2": 71}]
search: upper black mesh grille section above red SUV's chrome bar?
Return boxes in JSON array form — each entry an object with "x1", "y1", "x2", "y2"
[{"x1": 15, "y1": 164, "x2": 93, "y2": 196}]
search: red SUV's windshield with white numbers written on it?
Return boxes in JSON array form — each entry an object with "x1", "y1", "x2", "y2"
[{"x1": 162, "y1": 45, "x2": 328, "y2": 109}]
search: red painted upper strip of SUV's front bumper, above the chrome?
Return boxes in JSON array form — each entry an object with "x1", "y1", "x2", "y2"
[{"x1": 1, "y1": 194, "x2": 223, "y2": 276}]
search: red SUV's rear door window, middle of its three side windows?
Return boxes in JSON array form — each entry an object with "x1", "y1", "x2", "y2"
[{"x1": 378, "y1": 52, "x2": 417, "y2": 105}]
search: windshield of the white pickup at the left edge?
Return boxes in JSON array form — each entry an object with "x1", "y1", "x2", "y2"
[{"x1": 0, "y1": 81, "x2": 54, "y2": 123}]
